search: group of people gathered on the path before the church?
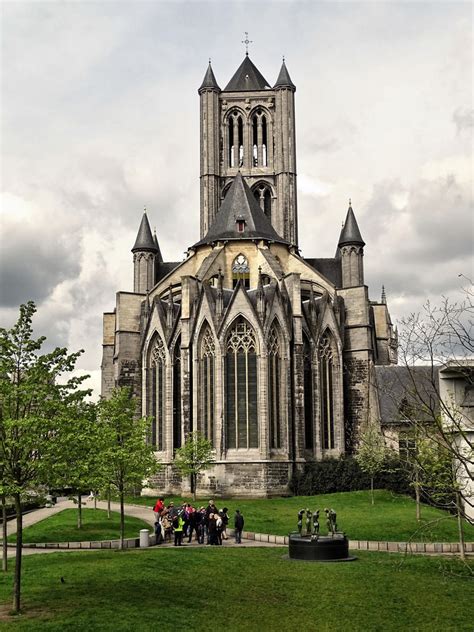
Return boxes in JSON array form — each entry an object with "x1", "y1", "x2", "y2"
[{"x1": 153, "y1": 498, "x2": 244, "y2": 546}]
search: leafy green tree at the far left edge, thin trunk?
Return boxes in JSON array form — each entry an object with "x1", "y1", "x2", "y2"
[{"x1": 0, "y1": 301, "x2": 88, "y2": 613}]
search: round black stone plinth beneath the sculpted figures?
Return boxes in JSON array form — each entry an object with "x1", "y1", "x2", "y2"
[{"x1": 289, "y1": 533, "x2": 356, "y2": 562}]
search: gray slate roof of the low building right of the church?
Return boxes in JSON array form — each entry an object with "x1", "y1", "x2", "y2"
[{"x1": 375, "y1": 366, "x2": 439, "y2": 424}]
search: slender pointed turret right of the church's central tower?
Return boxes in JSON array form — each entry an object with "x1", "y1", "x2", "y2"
[{"x1": 337, "y1": 200, "x2": 365, "y2": 288}]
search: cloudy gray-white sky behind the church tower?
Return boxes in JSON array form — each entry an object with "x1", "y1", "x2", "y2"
[{"x1": 0, "y1": 0, "x2": 474, "y2": 394}]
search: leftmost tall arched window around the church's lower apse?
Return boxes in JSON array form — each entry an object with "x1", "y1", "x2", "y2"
[{"x1": 150, "y1": 336, "x2": 166, "y2": 450}]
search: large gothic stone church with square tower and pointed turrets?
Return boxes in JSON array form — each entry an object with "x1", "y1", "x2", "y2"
[{"x1": 102, "y1": 53, "x2": 397, "y2": 497}]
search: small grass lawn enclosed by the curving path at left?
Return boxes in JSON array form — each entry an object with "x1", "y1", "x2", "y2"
[{"x1": 8, "y1": 509, "x2": 152, "y2": 543}]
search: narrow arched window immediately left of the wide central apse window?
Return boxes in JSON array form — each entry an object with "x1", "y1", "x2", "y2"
[{"x1": 198, "y1": 325, "x2": 216, "y2": 444}]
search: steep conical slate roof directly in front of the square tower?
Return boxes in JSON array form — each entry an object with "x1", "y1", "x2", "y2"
[{"x1": 195, "y1": 171, "x2": 288, "y2": 246}]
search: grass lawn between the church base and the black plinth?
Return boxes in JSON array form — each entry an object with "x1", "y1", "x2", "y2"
[{"x1": 122, "y1": 490, "x2": 474, "y2": 542}]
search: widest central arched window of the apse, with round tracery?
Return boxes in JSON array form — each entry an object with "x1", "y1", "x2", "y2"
[{"x1": 225, "y1": 317, "x2": 258, "y2": 449}]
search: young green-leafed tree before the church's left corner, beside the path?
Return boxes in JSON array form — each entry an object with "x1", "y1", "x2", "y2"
[{"x1": 97, "y1": 387, "x2": 160, "y2": 548}]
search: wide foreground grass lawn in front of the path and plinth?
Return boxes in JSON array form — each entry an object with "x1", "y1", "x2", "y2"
[{"x1": 0, "y1": 547, "x2": 472, "y2": 632}]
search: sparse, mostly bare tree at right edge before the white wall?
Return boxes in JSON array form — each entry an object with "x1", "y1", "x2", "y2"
[{"x1": 399, "y1": 282, "x2": 474, "y2": 559}]
